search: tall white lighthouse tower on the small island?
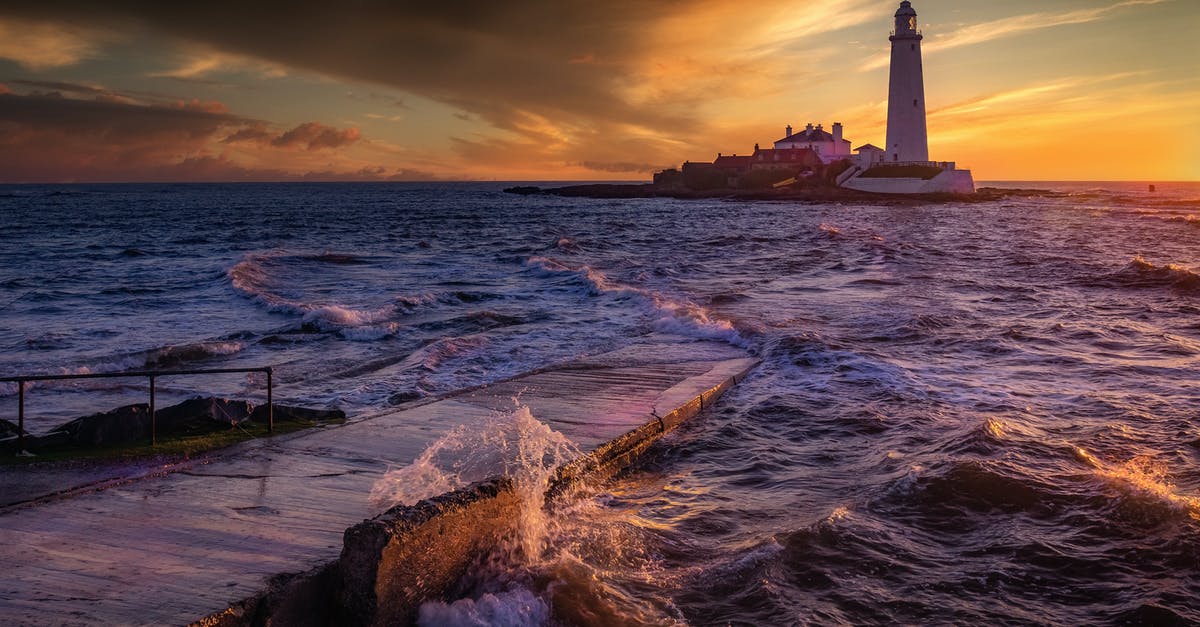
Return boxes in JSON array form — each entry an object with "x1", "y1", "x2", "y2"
[{"x1": 886, "y1": 0, "x2": 929, "y2": 162}]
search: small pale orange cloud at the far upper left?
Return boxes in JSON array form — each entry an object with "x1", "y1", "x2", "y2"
[{"x1": 0, "y1": 18, "x2": 113, "y2": 71}]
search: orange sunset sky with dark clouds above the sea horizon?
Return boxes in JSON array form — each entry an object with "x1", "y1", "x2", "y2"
[{"x1": 0, "y1": 0, "x2": 1200, "y2": 183}]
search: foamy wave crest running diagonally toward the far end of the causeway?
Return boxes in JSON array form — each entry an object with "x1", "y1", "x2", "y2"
[{"x1": 526, "y1": 256, "x2": 750, "y2": 348}]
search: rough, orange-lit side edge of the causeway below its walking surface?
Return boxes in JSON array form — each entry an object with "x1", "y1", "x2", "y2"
[{"x1": 199, "y1": 359, "x2": 760, "y2": 627}]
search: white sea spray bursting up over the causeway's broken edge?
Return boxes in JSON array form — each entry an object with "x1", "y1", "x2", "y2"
[{"x1": 371, "y1": 402, "x2": 679, "y2": 626}]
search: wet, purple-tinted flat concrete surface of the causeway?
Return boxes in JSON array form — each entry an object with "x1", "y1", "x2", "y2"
[{"x1": 0, "y1": 336, "x2": 754, "y2": 625}]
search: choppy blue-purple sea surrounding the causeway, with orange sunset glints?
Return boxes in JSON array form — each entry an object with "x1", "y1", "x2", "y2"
[{"x1": 0, "y1": 181, "x2": 1200, "y2": 625}]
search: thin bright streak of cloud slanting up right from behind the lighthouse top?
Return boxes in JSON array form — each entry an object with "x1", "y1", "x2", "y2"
[{"x1": 860, "y1": 0, "x2": 1174, "y2": 71}]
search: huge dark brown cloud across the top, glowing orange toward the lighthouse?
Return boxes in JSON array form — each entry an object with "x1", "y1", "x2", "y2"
[{"x1": 2, "y1": 0, "x2": 878, "y2": 133}]
